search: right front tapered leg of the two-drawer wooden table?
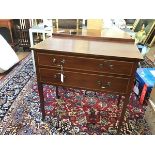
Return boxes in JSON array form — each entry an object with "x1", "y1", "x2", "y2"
[{"x1": 117, "y1": 95, "x2": 130, "y2": 134}]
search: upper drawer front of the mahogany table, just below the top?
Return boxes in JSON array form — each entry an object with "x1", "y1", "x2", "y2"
[{"x1": 38, "y1": 53, "x2": 133, "y2": 75}]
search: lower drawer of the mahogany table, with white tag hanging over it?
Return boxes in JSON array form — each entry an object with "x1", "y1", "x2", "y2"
[{"x1": 39, "y1": 68, "x2": 130, "y2": 93}]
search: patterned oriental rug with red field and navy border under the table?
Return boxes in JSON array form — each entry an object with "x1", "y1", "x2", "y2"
[{"x1": 0, "y1": 55, "x2": 151, "y2": 135}]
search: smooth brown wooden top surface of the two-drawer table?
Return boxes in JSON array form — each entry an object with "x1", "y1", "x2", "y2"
[{"x1": 31, "y1": 37, "x2": 143, "y2": 61}]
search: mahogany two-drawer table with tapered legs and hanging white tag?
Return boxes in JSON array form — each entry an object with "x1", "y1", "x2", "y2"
[{"x1": 32, "y1": 37, "x2": 142, "y2": 133}]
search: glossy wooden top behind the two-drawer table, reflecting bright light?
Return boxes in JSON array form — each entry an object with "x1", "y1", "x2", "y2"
[{"x1": 53, "y1": 26, "x2": 134, "y2": 42}]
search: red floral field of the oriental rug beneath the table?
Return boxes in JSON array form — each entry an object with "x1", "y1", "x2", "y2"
[{"x1": 34, "y1": 82, "x2": 148, "y2": 135}]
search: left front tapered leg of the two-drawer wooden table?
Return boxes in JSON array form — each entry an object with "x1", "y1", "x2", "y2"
[{"x1": 38, "y1": 82, "x2": 45, "y2": 121}]
